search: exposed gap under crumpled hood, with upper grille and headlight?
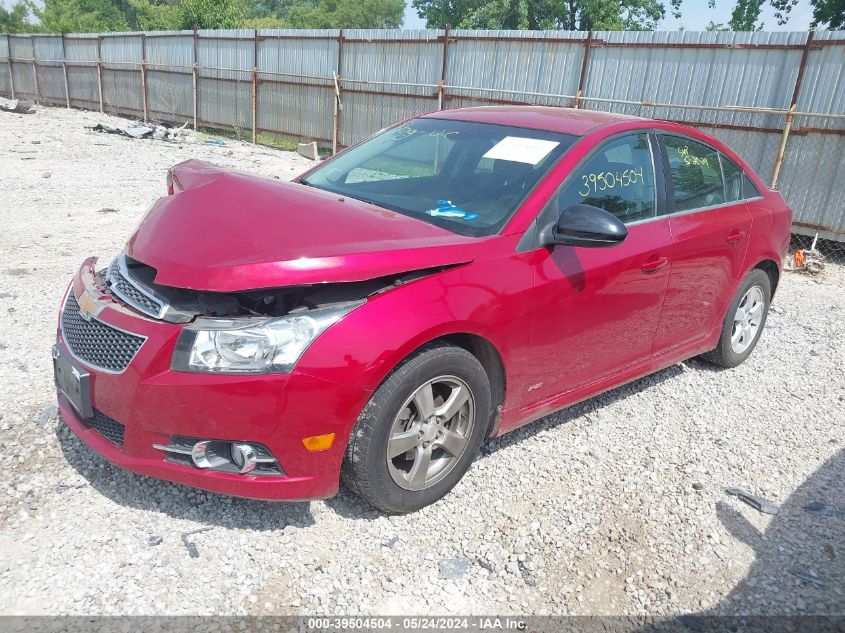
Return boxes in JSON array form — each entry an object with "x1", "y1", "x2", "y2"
[{"x1": 100, "y1": 249, "x2": 442, "y2": 373}]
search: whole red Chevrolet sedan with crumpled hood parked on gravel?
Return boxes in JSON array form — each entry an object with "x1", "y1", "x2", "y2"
[{"x1": 54, "y1": 107, "x2": 791, "y2": 512}]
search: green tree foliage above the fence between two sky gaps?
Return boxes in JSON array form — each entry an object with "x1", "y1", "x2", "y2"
[{"x1": 413, "y1": 0, "x2": 674, "y2": 31}]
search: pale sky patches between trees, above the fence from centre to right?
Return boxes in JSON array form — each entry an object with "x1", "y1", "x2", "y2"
[{"x1": 403, "y1": 0, "x2": 813, "y2": 31}]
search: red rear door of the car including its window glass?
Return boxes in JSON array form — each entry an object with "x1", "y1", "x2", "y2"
[{"x1": 654, "y1": 133, "x2": 751, "y2": 353}]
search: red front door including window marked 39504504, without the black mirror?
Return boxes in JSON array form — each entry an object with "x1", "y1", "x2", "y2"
[{"x1": 525, "y1": 132, "x2": 672, "y2": 407}]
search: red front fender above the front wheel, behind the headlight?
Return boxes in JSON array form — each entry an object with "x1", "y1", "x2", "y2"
[{"x1": 297, "y1": 250, "x2": 533, "y2": 400}]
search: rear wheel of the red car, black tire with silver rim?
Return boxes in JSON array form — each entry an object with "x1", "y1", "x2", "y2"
[{"x1": 701, "y1": 268, "x2": 772, "y2": 368}]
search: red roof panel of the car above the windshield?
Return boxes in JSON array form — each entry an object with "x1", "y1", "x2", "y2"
[{"x1": 423, "y1": 105, "x2": 651, "y2": 136}]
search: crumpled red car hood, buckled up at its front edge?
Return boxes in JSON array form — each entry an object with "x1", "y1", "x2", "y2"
[{"x1": 126, "y1": 161, "x2": 486, "y2": 292}]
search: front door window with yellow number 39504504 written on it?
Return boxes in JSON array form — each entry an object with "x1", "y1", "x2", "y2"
[{"x1": 551, "y1": 133, "x2": 657, "y2": 223}]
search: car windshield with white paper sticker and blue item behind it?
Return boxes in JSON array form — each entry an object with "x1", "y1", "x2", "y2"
[{"x1": 300, "y1": 117, "x2": 577, "y2": 236}]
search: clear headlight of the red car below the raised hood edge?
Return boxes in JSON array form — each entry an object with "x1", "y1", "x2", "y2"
[{"x1": 171, "y1": 303, "x2": 361, "y2": 374}]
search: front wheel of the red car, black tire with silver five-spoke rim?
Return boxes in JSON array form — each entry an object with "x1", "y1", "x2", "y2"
[{"x1": 341, "y1": 343, "x2": 491, "y2": 514}]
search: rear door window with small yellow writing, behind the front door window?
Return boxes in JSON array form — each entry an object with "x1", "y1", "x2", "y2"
[{"x1": 663, "y1": 135, "x2": 725, "y2": 211}]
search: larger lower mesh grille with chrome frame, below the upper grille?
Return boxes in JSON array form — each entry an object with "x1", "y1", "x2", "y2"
[{"x1": 62, "y1": 292, "x2": 145, "y2": 372}]
